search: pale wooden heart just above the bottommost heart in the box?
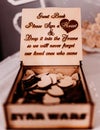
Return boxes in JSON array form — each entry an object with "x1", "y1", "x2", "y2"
[{"x1": 47, "y1": 85, "x2": 64, "y2": 96}]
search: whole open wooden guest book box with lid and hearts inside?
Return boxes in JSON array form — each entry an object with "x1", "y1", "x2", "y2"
[{"x1": 4, "y1": 8, "x2": 94, "y2": 128}]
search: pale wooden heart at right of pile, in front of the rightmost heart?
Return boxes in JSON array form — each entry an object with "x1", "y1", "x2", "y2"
[{"x1": 58, "y1": 76, "x2": 73, "y2": 87}]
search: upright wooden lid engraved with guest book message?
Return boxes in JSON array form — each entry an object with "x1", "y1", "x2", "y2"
[{"x1": 20, "y1": 8, "x2": 82, "y2": 65}]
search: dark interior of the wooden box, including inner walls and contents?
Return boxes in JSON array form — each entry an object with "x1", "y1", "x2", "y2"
[{"x1": 8, "y1": 66, "x2": 91, "y2": 105}]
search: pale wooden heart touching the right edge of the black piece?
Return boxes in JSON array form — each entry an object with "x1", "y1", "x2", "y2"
[{"x1": 37, "y1": 75, "x2": 52, "y2": 88}]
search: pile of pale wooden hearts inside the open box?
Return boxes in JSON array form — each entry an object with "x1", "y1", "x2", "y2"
[{"x1": 22, "y1": 70, "x2": 79, "y2": 104}]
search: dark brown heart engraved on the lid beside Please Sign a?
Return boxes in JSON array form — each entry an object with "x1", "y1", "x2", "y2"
[{"x1": 60, "y1": 19, "x2": 78, "y2": 33}]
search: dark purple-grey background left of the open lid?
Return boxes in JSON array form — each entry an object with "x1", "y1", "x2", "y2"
[{"x1": 0, "y1": 0, "x2": 40, "y2": 60}]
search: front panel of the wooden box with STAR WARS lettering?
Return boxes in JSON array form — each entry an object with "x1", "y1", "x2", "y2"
[{"x1": 7, "y1": 104, "x2": 91, "y2": 128}]
